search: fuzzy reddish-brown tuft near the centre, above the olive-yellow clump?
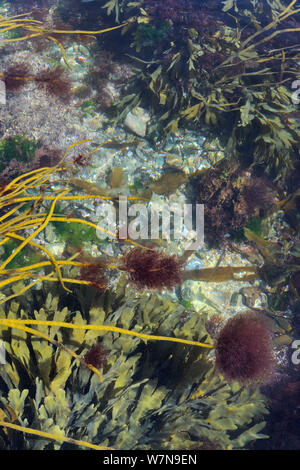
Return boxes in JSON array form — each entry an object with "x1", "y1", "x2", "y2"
[{"x1": 120, "y1": 247, "x2": 183, "y2": 290}]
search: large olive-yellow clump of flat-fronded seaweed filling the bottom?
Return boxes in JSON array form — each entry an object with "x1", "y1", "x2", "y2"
[{"x1": 0, "y1": 283, "x2": 267, "y2": 450}]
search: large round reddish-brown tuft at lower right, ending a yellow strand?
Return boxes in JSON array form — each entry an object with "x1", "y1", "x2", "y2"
[{"x1": 216, "y1": 312, "x2": 275, "y2": 384}]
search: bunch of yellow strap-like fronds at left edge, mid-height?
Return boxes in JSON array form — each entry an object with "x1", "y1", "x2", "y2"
[{"x1": 0, "y1": 141, "x2": 119, "y2": 303}]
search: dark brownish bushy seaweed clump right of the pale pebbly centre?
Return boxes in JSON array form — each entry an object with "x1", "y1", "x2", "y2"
[{"x1": 187, "y1": 160, "x2": 276, "y2": 244}]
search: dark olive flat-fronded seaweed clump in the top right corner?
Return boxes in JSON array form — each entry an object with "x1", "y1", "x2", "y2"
[{"x1": 108, "y1": 0, "x2": 300, "y2": 175}]
